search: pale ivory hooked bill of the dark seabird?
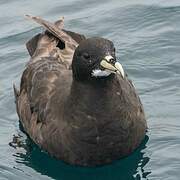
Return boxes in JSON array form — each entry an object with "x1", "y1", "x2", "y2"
[{"x1": 100, "y1": 56, "x2": 124, "y2": 78}]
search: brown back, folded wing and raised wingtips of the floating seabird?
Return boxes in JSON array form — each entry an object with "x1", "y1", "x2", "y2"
[{"x1": 14, "y1": 17, "x2": 85, "y2": 160}]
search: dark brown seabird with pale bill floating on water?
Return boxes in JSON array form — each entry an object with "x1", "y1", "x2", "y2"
[{"x1": 14, "y1": 15, "x2": 147, "y2": 167}]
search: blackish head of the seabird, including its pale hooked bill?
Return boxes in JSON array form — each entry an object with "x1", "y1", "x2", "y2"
[{"x1": 72, "y1": 38, "x2": 124, "y2": 80}]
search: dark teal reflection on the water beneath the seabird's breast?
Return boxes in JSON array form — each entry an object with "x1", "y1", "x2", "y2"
[{"x1": 14, "y1": 127, "x2": 151, "y2": 180}]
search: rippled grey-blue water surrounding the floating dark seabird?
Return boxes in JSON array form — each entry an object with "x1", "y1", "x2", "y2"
[{"x1": 0, "y1": 0, "x2": 180, "y2": 180}]
